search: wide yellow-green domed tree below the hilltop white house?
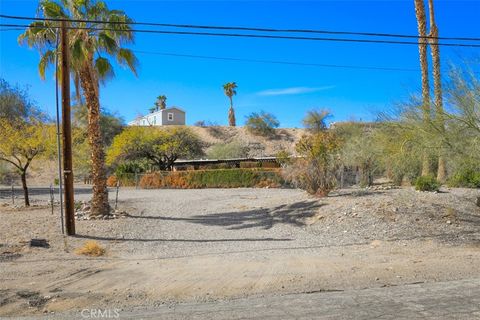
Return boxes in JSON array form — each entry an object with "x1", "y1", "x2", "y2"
[{"x1": 107, "y1": 127, "x2": 203, "y2": 170}]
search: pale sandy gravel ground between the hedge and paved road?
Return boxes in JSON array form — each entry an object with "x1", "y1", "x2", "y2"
[{"x1": 0, "y1": 188, "x2": 480, "y2": 316}]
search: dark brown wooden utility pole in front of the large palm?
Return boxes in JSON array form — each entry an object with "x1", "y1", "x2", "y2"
[{"x1": 60, "y1": 21, "x2": 75, "y2": 236}]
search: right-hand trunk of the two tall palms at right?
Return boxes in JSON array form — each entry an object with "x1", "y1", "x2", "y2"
[{"x1": 428, "y1": 0, "x2": 447, "y2": 182}]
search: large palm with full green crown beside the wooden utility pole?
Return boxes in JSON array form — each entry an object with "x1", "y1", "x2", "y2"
[{"x1": 19, "y1": 0, "x2": 137, "y2": 216}]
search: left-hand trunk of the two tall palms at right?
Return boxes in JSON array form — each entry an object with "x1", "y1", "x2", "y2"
[{"x1": 413, "y1": 0, "x2": 431, "y2": 175}]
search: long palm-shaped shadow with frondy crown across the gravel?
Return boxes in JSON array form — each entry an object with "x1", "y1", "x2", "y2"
[{"x1": 129, "y1": 201, "x2": 324, "y2": 230}]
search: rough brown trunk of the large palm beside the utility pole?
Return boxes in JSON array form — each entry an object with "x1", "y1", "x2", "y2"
[{"x1": 80, "y1": 65, "x2": 110, "y2": 216}]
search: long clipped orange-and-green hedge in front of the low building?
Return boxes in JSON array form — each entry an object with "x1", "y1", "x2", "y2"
[{"x1": 140, "y1": 169, "x2": 285, "y2": 189}]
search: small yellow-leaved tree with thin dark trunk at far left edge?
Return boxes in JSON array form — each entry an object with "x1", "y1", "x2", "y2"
[{"x1": 0, "y1": 119, "x2": 54, "y2": 207}]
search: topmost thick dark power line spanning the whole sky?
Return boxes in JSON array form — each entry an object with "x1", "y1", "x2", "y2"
[{"x1": 0, "y1": 14, "x2": 480, "y2": 41}]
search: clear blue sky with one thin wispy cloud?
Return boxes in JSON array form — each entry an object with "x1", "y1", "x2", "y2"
[{"x1": 0, "y1": 0, "x2": 480, "y2": 127}]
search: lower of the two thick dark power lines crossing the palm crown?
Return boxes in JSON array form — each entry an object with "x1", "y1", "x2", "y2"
[{"x1": 0, "y1": 24, "x2": 480, "y2": 48}]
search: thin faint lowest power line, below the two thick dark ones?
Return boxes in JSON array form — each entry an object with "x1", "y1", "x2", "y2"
[{"x1": 132, "y1": 50, "x2": 420, "y2": 72}]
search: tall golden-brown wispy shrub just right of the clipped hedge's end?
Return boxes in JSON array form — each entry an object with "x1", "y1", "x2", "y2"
[{"x1": 284, "y1": 130, "x2": 339, "y2": 196}]
